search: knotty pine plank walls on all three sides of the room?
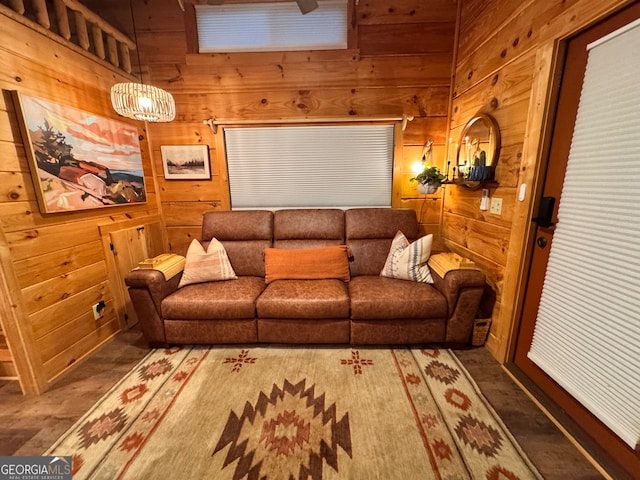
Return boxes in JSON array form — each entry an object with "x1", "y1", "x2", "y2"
[{"x1": 5, "y1": 0, "x2": 629, "y2": 391}]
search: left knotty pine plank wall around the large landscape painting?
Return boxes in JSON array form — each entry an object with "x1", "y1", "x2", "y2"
[{"x1": 0, "y1": 15, "x2": 159, "y2": 393}]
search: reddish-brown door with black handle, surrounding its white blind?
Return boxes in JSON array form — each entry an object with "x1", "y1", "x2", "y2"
[{"x1": 514, "y1": 2, "x2": 640, "y2": 472}]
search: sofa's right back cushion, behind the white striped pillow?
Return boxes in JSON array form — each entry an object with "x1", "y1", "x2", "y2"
[{"x1": 345, "y1": 208, "x2": 420, "y2": 277}]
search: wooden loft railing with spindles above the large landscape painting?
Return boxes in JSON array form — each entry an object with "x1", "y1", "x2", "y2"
[{"x1": 0, "y1": 0, "x2": 136, "y2": 74}]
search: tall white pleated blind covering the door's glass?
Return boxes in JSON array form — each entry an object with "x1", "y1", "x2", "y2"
[{"x1": 529, "y1": 18, "x2": 640, "y2": 448}]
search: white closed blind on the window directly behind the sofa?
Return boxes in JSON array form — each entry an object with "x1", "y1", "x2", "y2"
[{"x1": 224, "y1": 125, "x2": 394, "y2": 208}]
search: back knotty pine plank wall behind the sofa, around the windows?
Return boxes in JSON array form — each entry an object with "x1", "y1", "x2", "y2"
[{"x1": 89, "y1": 0, "x2": 457, "y2": 255}]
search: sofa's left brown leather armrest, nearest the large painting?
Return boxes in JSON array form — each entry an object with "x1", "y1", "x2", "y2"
[{"x1": 124, "y1": 270, "x2": 182, "y2": 347}]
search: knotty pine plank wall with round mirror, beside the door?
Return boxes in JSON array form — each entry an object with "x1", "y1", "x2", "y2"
[{"x1": 442, "y1": 0, "x2": 630, "y2": 360}]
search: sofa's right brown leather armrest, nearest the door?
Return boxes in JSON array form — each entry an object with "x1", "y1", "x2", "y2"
[{"x1": 431, "y1": 269, "x2": 485, "y2": 344}]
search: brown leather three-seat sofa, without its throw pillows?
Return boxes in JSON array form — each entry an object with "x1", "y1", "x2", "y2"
[{"x1": 125, "y1": 208, "x2": 485, "y2": 346}]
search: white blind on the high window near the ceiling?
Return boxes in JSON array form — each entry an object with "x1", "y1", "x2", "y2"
[{"x1": 195, "y1": 0, "x2": 347, "y2": 53}]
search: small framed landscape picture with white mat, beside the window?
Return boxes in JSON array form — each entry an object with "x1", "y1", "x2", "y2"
[{"x1": 160, "y1": 145, "x2": 211, "y2": 180}]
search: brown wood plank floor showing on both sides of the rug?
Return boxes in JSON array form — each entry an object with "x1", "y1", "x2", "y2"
[{"x1": 0, "y1": 329, "x2": 619, "y2": 480}]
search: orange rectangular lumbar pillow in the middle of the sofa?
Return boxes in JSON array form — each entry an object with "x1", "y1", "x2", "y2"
[{"x1": 264, "y1": 245, "x2": 351, "y2": 283}]
